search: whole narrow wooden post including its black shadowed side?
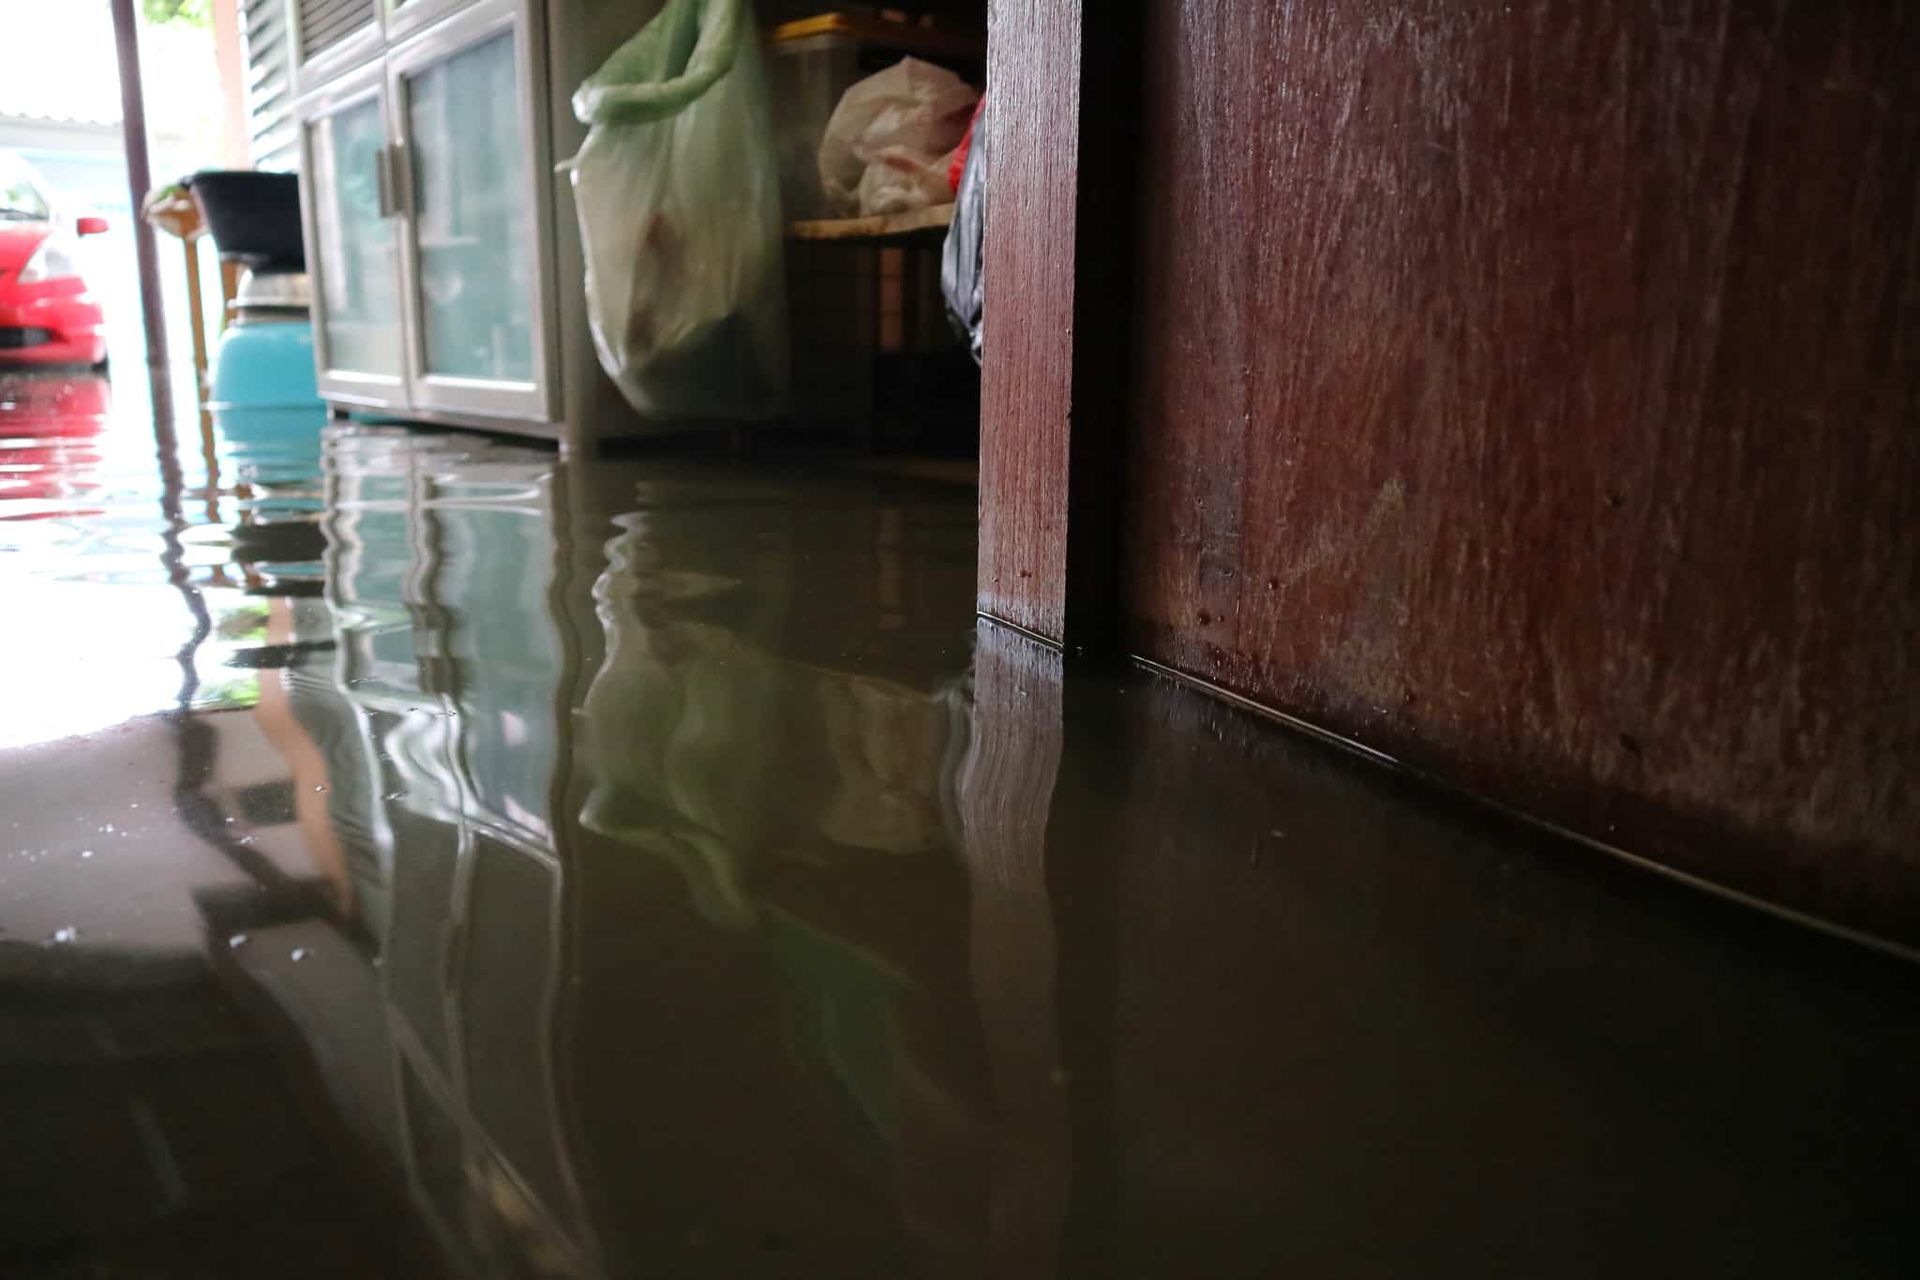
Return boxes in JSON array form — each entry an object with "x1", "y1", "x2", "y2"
[{"x1": 979, "y1": 0, "x2": 1140, "y2": 652}]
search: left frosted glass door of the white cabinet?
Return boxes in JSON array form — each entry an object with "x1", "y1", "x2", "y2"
[{"x1": 303, "y1": 79, "x2": 405, "y2": 403}]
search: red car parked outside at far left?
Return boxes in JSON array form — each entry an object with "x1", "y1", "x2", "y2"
[{"x1": 0, "y1": 152, "x2": 108, "y2": 367}]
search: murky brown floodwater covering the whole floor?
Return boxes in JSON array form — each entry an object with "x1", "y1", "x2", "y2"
[{"x1": 0, "y1": 364, "x2": 1920, "y2": 1280}]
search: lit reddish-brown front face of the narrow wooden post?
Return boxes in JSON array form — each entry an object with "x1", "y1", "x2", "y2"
[{"x1": 979, "y1": 0, "x2": 1081, "y2": 641}]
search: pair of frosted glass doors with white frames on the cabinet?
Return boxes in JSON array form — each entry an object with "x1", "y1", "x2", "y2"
[{"x1": 294, "y1": 0, "x2": 559, "y2": 434}]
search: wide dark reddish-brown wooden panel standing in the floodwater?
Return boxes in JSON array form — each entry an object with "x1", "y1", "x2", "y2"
[{"x1": 1121, "y1": 0, "x2": 1920, "y2": 942}]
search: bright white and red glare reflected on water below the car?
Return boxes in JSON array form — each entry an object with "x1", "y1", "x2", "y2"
[{"x1": 0, "y1": 374, "x2": 295, "y2": 748}]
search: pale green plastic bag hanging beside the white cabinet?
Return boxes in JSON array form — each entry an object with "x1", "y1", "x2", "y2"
[{"x1": 568, "y1": 0, "x2": 787, "y2": 420}]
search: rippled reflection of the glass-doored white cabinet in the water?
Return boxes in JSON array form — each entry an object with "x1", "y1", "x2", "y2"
[{"x1": 314, "y1": 430, "x2": 591, "y2": 1274}]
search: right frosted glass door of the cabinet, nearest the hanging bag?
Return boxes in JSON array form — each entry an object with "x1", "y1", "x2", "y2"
[{"x1": 394, "y1": 6, "x2": 541, "y2": 416}]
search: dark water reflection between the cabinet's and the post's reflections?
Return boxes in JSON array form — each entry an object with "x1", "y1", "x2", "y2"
[{"x1": 574, "y1": 470, "x2": 993, "y2": 1274}]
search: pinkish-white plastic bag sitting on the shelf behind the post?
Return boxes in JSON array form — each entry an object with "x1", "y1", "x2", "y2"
[{"x1": 820, "y1": 58, "x2": 979, "y2": 215}]
